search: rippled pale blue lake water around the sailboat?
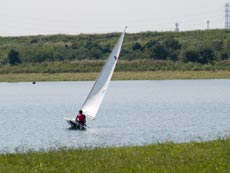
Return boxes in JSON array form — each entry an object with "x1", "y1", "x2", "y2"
[{"x1": 0, "y1": 79, "x2": 230, "y2": 152}]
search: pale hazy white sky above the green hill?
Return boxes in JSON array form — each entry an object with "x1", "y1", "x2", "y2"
[{"x1": 0, "y1": 0, "x2": 230, "y2": 36}]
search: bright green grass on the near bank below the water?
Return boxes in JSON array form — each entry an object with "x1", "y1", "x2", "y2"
[{"x1": 0, "y1": 139, "x2": 230, "y2": 173}]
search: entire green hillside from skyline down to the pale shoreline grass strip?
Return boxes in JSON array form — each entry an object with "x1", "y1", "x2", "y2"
[{"x1": 0, "y1": 30, "x2": 230, "y2": 73}]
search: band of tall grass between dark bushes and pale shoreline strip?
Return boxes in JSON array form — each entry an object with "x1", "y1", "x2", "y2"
[{"x1": 0, "y1": 60, "x2": 230, "y2": 74}]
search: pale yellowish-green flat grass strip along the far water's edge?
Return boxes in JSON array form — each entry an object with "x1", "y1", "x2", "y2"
[{"x1": 0, "y1": 70, "x2": 230, "y2": 82}]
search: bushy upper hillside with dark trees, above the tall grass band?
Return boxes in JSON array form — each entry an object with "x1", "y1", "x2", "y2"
[{"x1": 0, "y1": 30, "x2": 230, "y2": 66}]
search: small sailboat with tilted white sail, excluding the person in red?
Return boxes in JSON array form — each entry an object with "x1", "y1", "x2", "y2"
[{"x1": 66, "y1": 27, "x2": 127, "y2": 130}]
